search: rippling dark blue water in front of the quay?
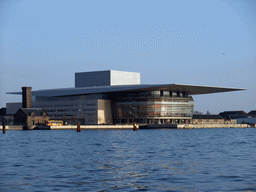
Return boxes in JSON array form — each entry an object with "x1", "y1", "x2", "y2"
[{"x1": 0, "y1": 128, "x2": 256, "y2": 191}]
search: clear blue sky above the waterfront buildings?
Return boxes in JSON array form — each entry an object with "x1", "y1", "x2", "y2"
[{"x1": 0, "y1": 0, "x2": 256, "y2": 113}]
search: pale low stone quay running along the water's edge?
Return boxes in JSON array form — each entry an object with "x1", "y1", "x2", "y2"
[{"x1": 0, "y1": 124, "x2": 256, "y2": 130}]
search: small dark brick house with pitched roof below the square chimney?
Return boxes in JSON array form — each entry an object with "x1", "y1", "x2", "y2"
[{"x1": 14, "y1": 108, "x2": 49, "y2": 128}]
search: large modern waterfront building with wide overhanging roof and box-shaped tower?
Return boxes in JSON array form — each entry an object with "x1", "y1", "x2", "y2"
[{"x1": 6, "y1": 70, "x2": 244, "y2": 124}]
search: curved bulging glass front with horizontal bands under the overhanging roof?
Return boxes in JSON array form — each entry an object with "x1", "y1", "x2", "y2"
[{"x1": 113, "y1": 91, "x2": 194, "y2": 124}]
